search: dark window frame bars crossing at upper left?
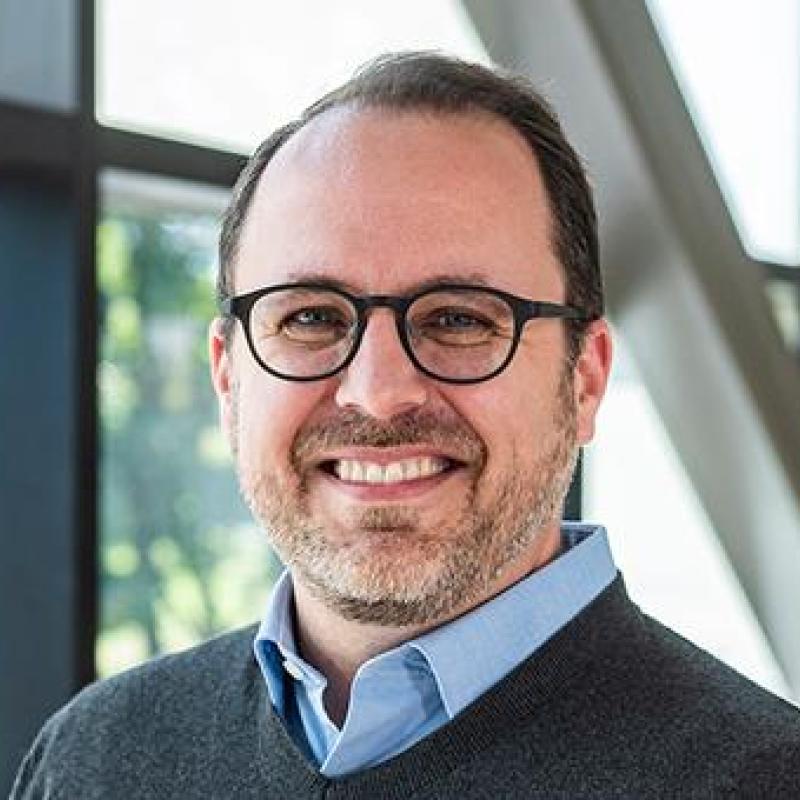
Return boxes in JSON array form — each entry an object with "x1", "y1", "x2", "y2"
[{"x1": 0, "y1": 0, "x2": 246, "y2": 690}]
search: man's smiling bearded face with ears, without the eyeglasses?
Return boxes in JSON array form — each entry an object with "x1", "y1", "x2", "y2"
[{"x1": 211, "y1": 110, "x2": 608, "y2": 625}]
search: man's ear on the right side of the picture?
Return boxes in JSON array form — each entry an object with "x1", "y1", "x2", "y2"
[{"x1": 573, "y1": 319, "x2": 612, "y2": 445}]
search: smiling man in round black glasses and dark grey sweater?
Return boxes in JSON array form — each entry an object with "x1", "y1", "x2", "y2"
[{"x1": 13, "y1": 54, "x2": 800, "y2": 798}]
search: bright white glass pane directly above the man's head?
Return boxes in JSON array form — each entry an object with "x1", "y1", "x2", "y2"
[{"x1": 97, "y1": 0, "x2": 486, "y2": 152}]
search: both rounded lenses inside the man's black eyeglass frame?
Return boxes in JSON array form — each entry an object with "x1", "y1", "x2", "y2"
[{"x1": 250, "y1": 287, "x2": 514, "y2": 380}]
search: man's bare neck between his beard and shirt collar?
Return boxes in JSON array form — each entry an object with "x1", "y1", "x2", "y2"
[{"x1": 292, "y1": 525, "x2": 560, "y2": 727}]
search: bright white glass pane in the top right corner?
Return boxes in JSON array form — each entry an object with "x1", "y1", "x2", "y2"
[{"x1": 648, "y1": 0, "x2": 800, "y2": 264}]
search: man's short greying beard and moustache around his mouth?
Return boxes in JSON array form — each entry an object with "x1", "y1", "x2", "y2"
[{"x1": 232, "y1": 369, "x2": 578, "y2": 626}]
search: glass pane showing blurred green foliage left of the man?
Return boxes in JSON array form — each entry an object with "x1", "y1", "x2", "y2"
[{"x1": 96, "y1": 173, "x2": 276, "y2": 675}]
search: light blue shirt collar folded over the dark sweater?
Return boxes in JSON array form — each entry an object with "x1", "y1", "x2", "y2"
[{"x1": 254, "y1": 522, "x2": 616, "y2": 718}]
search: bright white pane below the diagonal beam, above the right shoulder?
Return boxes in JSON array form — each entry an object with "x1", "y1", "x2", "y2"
[{"x1": 584, "y1": 328, "x2": 789, "y2": 698}]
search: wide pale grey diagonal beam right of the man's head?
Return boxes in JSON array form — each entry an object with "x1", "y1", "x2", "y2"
[{"x1": 464, "y1": 0, "x2": 800, "y2": 694}]
